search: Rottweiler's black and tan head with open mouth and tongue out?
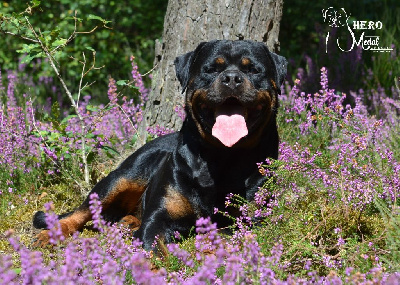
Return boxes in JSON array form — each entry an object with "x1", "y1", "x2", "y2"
[{"x1": 175, "y1": 40, "x2": 287, "y2": 147}]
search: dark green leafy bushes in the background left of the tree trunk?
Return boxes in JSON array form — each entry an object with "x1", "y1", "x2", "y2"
[{"x1": 0, "y1": 0, "x2": 167, "y2": 102}]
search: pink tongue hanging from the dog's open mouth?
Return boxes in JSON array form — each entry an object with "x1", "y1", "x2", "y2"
[{"x1": 212, "y1": 114, "x2": 248, "y2": 147}]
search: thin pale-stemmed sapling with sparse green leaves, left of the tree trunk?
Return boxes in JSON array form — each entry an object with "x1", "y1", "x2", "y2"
[{"x1": 0, "y1": 1, "x2": 125, "y2": 186}]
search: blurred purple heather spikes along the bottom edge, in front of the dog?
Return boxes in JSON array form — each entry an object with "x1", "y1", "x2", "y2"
[{"x1": 0, "y1": 194, "x2": 400, "y2": 284}]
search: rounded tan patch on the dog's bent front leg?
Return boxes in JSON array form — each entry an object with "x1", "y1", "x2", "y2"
[{"x1": 164, "y1": 187, "x2": 194, "y2": 220}]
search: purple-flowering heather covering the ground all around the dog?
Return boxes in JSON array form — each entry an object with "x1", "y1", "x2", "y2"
[{"x1": 0, "y1": 10, "x2": 400, "y2": 284}]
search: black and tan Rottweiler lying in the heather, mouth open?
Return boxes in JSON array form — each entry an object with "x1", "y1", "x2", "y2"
[{"x1": 33, "y1": 40, "x2": 286, "y2": 249}]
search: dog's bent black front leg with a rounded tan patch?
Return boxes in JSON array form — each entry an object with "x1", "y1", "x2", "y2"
[{"x1": 134, "y1": 155, "x2": 200, "y2": 253}]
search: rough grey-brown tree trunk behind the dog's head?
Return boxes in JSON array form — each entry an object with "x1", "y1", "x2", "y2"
[{"x1": 139, "y1": 0, "x2": 283, "y2": 145}]
